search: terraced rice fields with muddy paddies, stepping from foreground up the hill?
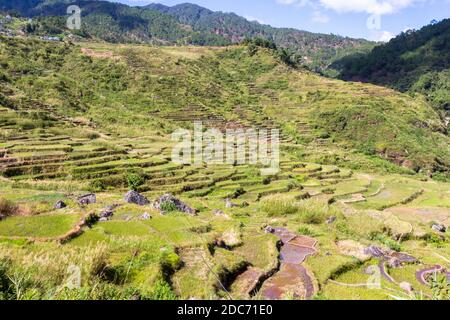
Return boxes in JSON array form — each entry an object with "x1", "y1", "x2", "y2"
[{"x1": 0, "y1": 38, "x2": 450, "y2": 299}]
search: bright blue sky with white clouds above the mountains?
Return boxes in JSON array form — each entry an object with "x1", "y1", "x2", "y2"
[{"x1": 115, "y1": 0, "x2": 450, "y2": 41}]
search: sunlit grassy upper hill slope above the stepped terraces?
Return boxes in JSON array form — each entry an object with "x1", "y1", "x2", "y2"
[{"x1": 2, "y1": 39, "x2": 450, "y2": 178}]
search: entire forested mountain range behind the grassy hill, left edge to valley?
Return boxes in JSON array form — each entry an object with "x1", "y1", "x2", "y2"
[{"x1": 0, "y1": 0, "x2": 374, "y2": 71}]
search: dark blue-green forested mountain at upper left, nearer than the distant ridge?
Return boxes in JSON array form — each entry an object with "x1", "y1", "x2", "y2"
[{"x1": 0, "y1": 0, "x2": 230, "y2": 45}]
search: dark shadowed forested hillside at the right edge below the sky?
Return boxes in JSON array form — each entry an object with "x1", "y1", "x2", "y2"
[{"x1": 331, "y1": 19, "x2": 450, "y2": 117}]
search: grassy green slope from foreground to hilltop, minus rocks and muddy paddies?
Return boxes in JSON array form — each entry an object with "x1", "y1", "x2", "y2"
[{"x1": 0, "y1": 39, "x2": 449, "y2": 299}]
